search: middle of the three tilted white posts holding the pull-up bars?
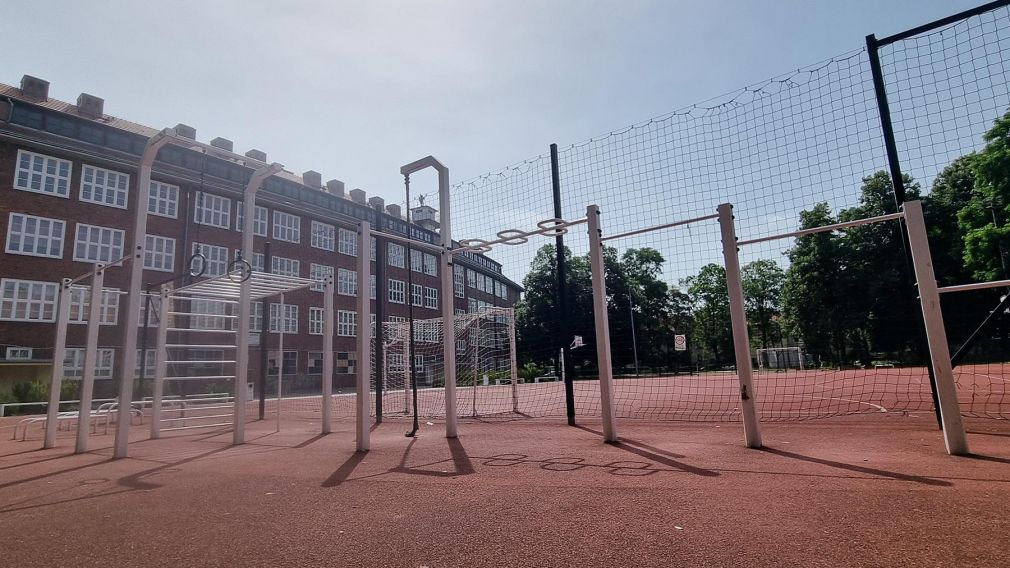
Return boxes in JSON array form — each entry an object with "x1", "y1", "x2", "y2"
[{"x1": 718, "y1": 203, "x2": 762, "y2": 448}]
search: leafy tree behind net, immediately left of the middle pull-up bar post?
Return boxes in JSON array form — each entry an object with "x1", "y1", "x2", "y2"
[{"x1": 684, "y1": 264, "x2": 733, "y2": 364}]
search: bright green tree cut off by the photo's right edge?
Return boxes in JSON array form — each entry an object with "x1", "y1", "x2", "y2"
[{"x1": 957, "y1": 108, "x2": 1010, "y2": 280}]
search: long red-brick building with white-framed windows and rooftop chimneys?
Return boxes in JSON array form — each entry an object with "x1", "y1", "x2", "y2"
[{"x1": 0, "y1": 76, "x2": 520, "y2": 396}]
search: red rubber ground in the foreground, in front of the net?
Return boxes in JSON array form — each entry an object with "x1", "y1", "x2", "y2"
[{"x1": 0, "y1": 412, "x2": 1010, "y2": 567}]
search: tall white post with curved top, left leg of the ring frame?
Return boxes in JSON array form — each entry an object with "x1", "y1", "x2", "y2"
[{"x1": 112, "y1": 129, "x2": 175, "y2": 458}]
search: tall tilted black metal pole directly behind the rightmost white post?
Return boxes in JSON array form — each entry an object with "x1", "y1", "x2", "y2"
[{"x1": 867, "y1": 33, "x2": 943, "y2": 430}]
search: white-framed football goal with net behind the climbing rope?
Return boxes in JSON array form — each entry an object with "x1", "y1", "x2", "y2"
[{"x1": 372, "y1": 307, "x2": 529, "y2": 418}]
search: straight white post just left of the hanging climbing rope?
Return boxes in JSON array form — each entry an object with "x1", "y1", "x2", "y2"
[{"x1": 355, "y1": 221, "x2": 372, "y2": 452}]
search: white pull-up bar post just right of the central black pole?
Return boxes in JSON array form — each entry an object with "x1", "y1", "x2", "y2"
[{"x1": 586, "y1": 205, "x2": 617, "y2": 442}]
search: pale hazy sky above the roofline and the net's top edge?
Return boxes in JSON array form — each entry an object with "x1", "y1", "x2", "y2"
[{"x1": 0, "y1": 0, "x2": 980, "y2": 200}]
